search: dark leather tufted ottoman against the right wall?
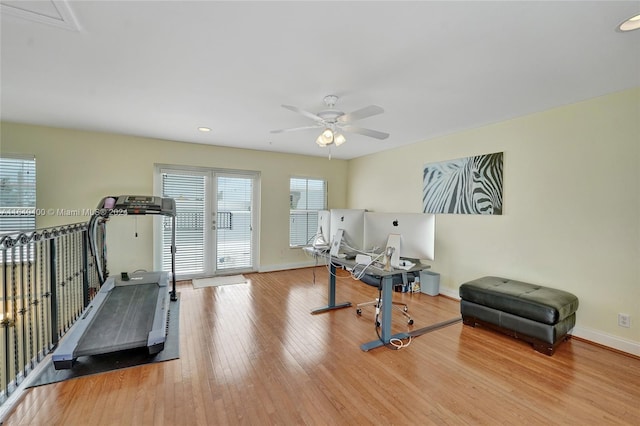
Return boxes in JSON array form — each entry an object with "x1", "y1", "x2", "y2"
[{"x1": 460, "y1": 277, "x2": 578, "y2": 355}]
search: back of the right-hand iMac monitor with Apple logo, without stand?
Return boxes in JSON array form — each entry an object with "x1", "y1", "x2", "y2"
[{"x1": 364, "y1": 212, "x2": 436, "y2": 260}]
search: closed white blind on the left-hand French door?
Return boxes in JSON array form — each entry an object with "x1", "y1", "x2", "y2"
[{"x1": 162, "y1": 173, "x2": 206, "y2": 275}]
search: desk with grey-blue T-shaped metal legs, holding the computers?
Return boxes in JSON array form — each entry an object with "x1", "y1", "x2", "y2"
[{"x1": 308, "y1": 248, "x2": 430, "y2": 352}]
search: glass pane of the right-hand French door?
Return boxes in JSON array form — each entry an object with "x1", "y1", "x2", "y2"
[{"x1": 216, "y1": 176, "x2": 253, "y2": 271}]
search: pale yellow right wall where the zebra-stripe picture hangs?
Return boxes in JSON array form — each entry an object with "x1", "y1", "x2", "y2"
[{"x1": 348, "y1": 88, "x2": 640, "y2": 355}]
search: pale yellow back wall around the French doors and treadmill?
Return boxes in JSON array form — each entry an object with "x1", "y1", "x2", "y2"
[{"x1": 0, "y1": 123, "x2": 347, "y2": 272}]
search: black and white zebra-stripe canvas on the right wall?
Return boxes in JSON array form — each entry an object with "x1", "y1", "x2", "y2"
[{"x1": 422, "y1": 152, "x2": 503, "y2": 215}]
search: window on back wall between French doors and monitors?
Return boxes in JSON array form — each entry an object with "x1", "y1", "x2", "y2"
[{"x1": 289, "y1": 177, "x2": 327, "y2": 247}]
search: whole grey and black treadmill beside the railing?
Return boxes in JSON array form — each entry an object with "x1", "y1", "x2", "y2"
[{"x1": 52, "y1": 195, "x2": 177, "y2": 370}]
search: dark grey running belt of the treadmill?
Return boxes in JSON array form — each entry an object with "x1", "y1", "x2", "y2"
[{"x1": 74, "y1": 283, "x2": 164, "y2": 356}]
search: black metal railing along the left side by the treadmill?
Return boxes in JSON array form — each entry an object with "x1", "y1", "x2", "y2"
[{"x1": 0, "y1": 222, "x2": 106, "y2": 404}]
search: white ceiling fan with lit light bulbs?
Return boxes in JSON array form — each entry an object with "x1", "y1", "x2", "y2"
[{"x1": 271, "y1": 95, "x2": 389, "y2": 147}]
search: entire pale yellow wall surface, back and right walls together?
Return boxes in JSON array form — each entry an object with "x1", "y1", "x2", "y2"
[{"x1": 0, "y1": 88, "x2": 640, "y2": 355}]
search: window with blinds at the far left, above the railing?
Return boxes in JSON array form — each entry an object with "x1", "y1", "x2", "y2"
[{"x1": 0, "y1": 155, "x2": 36, "y2": 232}]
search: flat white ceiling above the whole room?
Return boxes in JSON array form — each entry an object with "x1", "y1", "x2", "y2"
[{"x1": 0, "y1": 0, "x2": 640, "y2": 159}]
